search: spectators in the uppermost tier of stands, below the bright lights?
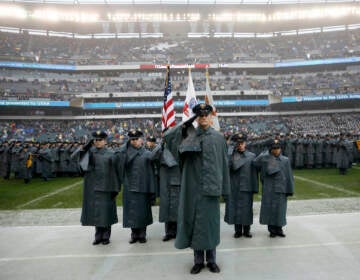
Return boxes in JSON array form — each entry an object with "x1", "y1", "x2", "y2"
[{"x1": 0, "y1": 30, "x2": 360, "y2": 65}]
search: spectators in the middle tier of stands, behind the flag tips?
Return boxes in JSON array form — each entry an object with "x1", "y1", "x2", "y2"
[{"x1": 0, "y1": 70, "x2": 360, "y2": 102}]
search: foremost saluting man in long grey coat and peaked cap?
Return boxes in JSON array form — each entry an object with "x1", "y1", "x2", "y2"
[{"x1": 165, "y1": 103, "x2": 230, "y2": 274}]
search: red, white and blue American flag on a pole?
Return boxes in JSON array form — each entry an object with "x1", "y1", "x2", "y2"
[{"x1": 161, "y1": 66, "x2": 176, "y2": 131}]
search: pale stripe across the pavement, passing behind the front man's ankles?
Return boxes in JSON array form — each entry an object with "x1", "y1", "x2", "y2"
[{"x1": 0, "y1": 241, "x2": 360, "y2": 263}]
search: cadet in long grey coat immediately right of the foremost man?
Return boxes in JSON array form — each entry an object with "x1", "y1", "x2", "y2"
[{"x1": 224, "y1": 133, "x2": 259, "y2": 238}]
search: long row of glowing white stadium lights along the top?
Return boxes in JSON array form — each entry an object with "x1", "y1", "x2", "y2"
[{"x1": 0, "y1": 0, "x2": 360, "y2": 23}]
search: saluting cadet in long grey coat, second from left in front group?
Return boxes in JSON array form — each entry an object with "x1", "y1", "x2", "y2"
[{"x1": 117, "y1": 130, "x2": 155, "y2": 244}]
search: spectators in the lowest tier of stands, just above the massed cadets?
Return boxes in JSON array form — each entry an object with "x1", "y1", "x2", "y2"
[{"x1": 0, "y1": 113, "x2": 360, "y2": 142}]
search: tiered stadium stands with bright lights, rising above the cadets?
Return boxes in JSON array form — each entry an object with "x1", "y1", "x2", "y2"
[{"x1": 0, "y1": 1, "x2": 360, "y2": 140}]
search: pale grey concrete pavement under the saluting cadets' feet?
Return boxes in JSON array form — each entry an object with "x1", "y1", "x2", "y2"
[{"x1": 0, "y1": 198, "x2": 360, "y2": 279}]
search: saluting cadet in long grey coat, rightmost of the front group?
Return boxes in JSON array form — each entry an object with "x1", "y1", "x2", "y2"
[{"x1": 253, "y1": 140, "x2": 294, "y2": 237}]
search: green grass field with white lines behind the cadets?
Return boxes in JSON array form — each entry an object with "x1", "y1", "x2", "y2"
[{"x1": 0, "y1": 166, "x2": 360, "y2": 210}]
